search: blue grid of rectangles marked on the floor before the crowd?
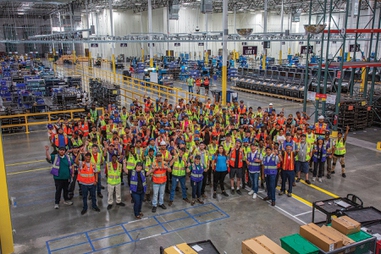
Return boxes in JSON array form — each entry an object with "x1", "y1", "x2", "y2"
[{"x1": 46, "y1": 203, "x2": 230, "y2": 254}]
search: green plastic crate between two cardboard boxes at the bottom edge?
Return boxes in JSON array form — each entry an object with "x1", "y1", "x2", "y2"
[{"x1": 280, "y1": 234, "x2": 319, "y2": 254}]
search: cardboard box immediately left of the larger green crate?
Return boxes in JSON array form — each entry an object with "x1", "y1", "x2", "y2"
[{"x1": 242, "y1": 235, "x2": 289, "y2": 254}]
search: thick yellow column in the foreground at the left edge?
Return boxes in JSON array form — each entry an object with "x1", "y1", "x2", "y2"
[{"x1": 0, "y1": 132, "x2": 14, "y2": 254}]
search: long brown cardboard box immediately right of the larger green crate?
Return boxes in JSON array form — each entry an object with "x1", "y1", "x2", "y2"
[{"x1": 299, "y1": 223, "x2": 342, "y2": 252}]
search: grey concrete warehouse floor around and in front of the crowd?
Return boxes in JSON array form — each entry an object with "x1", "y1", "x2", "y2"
[{"x1": 3, "y1": 66, "x2": 381, "y2": 254}]
